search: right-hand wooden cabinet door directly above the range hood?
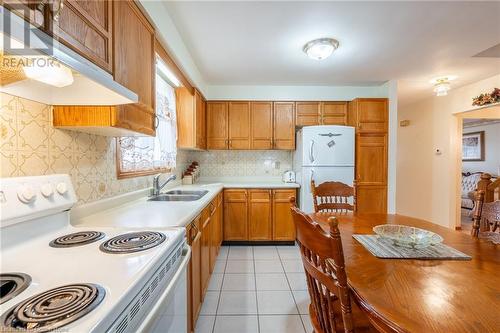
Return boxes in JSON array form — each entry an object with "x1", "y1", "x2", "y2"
[{"x1": 51, "y1": 0, "x2": 113, "y2": 73}]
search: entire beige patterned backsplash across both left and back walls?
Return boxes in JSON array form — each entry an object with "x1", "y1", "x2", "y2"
[{"x1": 0, "y1": 93, "x2": 292, "y2": 204}]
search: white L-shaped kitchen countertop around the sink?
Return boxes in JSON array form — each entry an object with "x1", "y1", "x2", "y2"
[{"x1": 71, "y1": 178, "x2": 299, "y2": 230}]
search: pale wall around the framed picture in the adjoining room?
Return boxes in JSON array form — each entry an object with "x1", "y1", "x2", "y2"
[{"x1": 462, "y1": 123, "x2": 500, "y2": 175}]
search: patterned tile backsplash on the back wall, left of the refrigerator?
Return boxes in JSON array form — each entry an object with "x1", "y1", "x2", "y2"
[{"x1": 188, "y1": 150, "x2": 292, "y2": 177}]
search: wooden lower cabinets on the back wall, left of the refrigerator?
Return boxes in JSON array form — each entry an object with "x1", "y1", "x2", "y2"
[{"x1": 224, "y1": 189, "x2": 296, "y2": 241}]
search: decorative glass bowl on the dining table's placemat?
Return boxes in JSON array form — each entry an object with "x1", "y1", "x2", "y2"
[{"x1": 373, "y1": 224, "x2": 443, "y2": 249}]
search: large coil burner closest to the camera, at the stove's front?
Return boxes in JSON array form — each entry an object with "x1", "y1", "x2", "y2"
[{"x1": 0, "y1": 283, "x2": 106, "y2": 332}]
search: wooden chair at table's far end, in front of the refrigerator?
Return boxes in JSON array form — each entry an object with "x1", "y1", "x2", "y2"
[{"x1": 311, "y1": 180, "x2": 356, "y2": 213}]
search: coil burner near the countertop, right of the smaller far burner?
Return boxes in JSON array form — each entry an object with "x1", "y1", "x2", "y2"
[{"x1": 100, "y1": 231, "x2": 167, "y2": 253}]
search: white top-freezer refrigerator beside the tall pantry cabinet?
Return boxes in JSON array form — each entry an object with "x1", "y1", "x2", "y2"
[{"x1": 293, "y1": 125, "x2": 354, "y2": 213}]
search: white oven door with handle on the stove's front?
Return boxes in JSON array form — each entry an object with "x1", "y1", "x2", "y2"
[{"x1": 137, "y1": 246, "x2": 191, "y2": 333}]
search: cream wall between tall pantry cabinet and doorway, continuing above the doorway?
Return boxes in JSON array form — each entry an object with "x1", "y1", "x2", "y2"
[{"x1": 396, "y1": 75, "x2": 500, "y2": 228}]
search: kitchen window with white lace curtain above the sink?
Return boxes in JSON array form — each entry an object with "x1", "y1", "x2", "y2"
[{"x1": 117, "y1": 59, "x2": 177, "y2": 178}]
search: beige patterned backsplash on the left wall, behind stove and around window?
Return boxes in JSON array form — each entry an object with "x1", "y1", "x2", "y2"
[{"x1": 0, "y1": 93, "x2": 186, "y2": 204}]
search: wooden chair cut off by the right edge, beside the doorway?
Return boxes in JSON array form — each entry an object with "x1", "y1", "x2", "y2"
[{"x1": 471, "y1": 190, "x2": 500, "y2": 244}]
